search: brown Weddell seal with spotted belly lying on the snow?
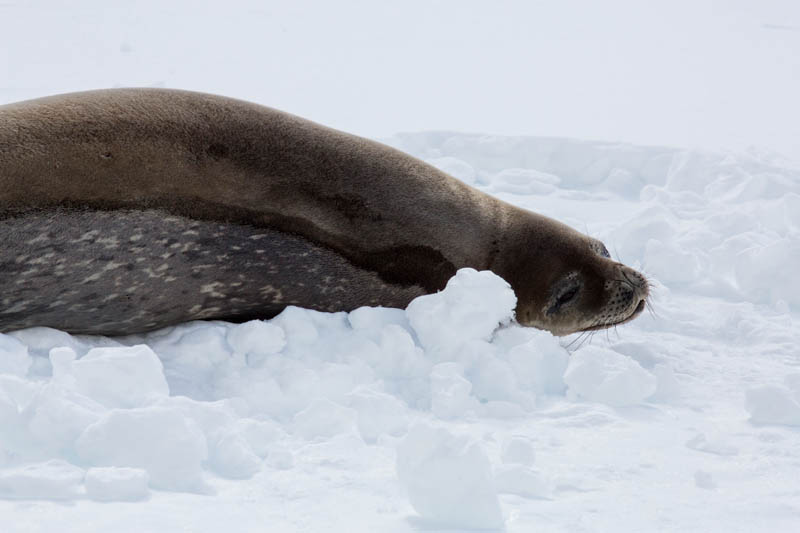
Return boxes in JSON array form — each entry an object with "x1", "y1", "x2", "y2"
[{"x1": 0, "y1": 89, "x2": 648, "y2": 335}]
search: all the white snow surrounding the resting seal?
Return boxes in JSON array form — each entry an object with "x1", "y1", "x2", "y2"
[{"x1": 0, "y1": 0, "x2": 800, "y2": 533}]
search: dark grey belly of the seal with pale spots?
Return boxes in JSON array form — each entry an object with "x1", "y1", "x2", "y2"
[{"x1": 0, "y1": 208, "x2": 423, "y2": 335}]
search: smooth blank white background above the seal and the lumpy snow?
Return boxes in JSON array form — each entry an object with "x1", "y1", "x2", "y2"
[{"x1": 0, "y1": 0, "x2": 800, "y2": 160}]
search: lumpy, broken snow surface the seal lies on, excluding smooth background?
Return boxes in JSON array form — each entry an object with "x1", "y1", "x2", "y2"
[{"x1": 0, "y1": 132, "x2": 800, "y2": 532}]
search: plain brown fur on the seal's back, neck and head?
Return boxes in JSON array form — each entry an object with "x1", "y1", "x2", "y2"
[{"x1": 0, "y1": 89, "x2": 647, "y2": 334}]
